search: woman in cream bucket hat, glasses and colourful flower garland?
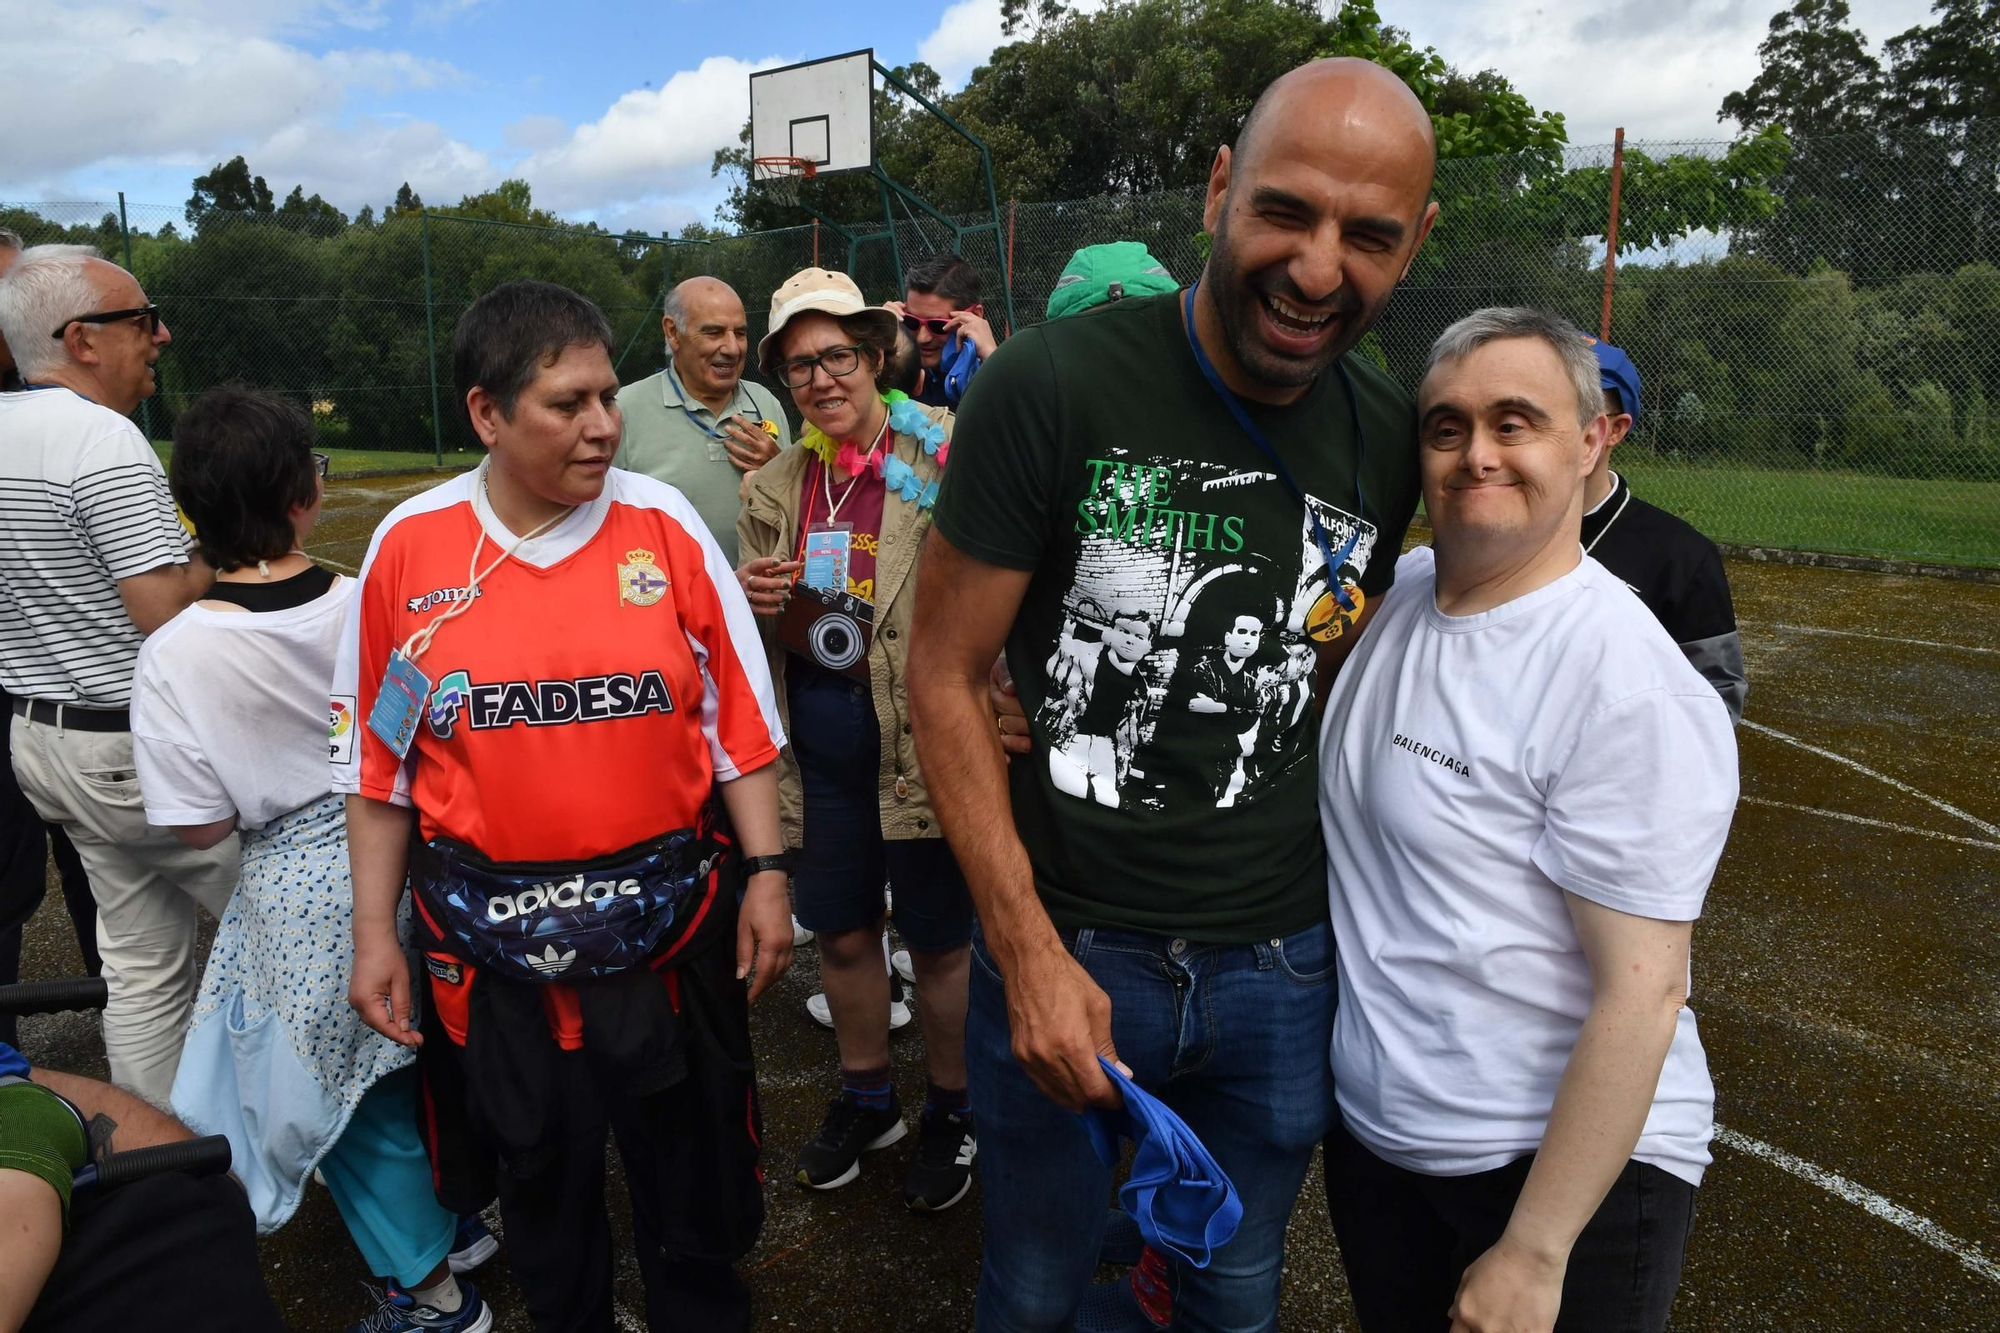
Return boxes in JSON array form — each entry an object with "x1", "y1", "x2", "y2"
[{"x1": 736, "y1": 268, "x2": 976, "y2": 1211}]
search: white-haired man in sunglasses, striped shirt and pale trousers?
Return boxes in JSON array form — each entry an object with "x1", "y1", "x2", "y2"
[{"x1": 0, "y1": 246, "x2": 236, "y2": 1101}]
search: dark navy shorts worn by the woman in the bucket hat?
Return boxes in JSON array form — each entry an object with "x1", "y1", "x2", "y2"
[{"x1": 784, "y1": 654, "x2": 972, "y2": 953}]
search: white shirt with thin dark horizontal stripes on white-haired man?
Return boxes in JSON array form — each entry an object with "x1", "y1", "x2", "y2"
[{"x1": 0, "y1": 388, "x2": 188, "y2": 709}]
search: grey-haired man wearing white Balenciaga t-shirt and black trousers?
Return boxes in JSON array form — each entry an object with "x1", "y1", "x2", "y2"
[{"x1": 1320, "y1": 308, "x2": 1736, "y2": 1333}]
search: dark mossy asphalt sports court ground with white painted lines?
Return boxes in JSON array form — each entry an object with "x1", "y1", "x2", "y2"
[{"x1": 7, "y1": 478, "x2": 2000, "y2": 1333}]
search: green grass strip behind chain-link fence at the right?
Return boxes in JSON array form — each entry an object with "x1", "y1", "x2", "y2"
[{"x1": 1614, "y1": 454, "x2": 2000, "y2": 566}]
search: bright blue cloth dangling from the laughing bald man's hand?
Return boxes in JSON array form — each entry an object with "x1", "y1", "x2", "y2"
[{"x1": 1082, "y1": 1055, "x2": 1244, "y2": 1269}]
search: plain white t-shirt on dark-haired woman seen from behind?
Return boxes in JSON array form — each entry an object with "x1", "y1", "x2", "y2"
[{"x1": 132, "y1": 578, "x2": 356, "y2": 829}]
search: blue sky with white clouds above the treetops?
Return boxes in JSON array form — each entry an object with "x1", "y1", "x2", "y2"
[{"x1": 0, "y1": 0, "x2": 1928, "y2": 232}]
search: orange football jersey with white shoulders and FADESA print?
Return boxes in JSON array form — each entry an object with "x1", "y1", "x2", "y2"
[{"x1": 330, "y1": 466, "x2": 784, "y2": 863}]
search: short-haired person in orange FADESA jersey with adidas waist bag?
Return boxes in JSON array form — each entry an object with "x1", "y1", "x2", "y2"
[{"x1": 332, "y1": 282, "x2": 792, "y2": 1333}]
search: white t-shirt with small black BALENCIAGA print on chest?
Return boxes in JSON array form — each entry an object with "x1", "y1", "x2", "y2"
[{"x1": 1320, "y1": 546, "x2": 1736, "y2": 1185}]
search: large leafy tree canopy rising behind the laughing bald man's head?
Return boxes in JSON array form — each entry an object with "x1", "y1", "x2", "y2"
[{"x1": 714, "y1": 0, "x2": 1564, "y2": 230}]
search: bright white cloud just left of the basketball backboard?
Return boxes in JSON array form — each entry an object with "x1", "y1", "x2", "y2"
[{"x1": 508, "y1": 56, "x2": 786, "y2": 210}]
